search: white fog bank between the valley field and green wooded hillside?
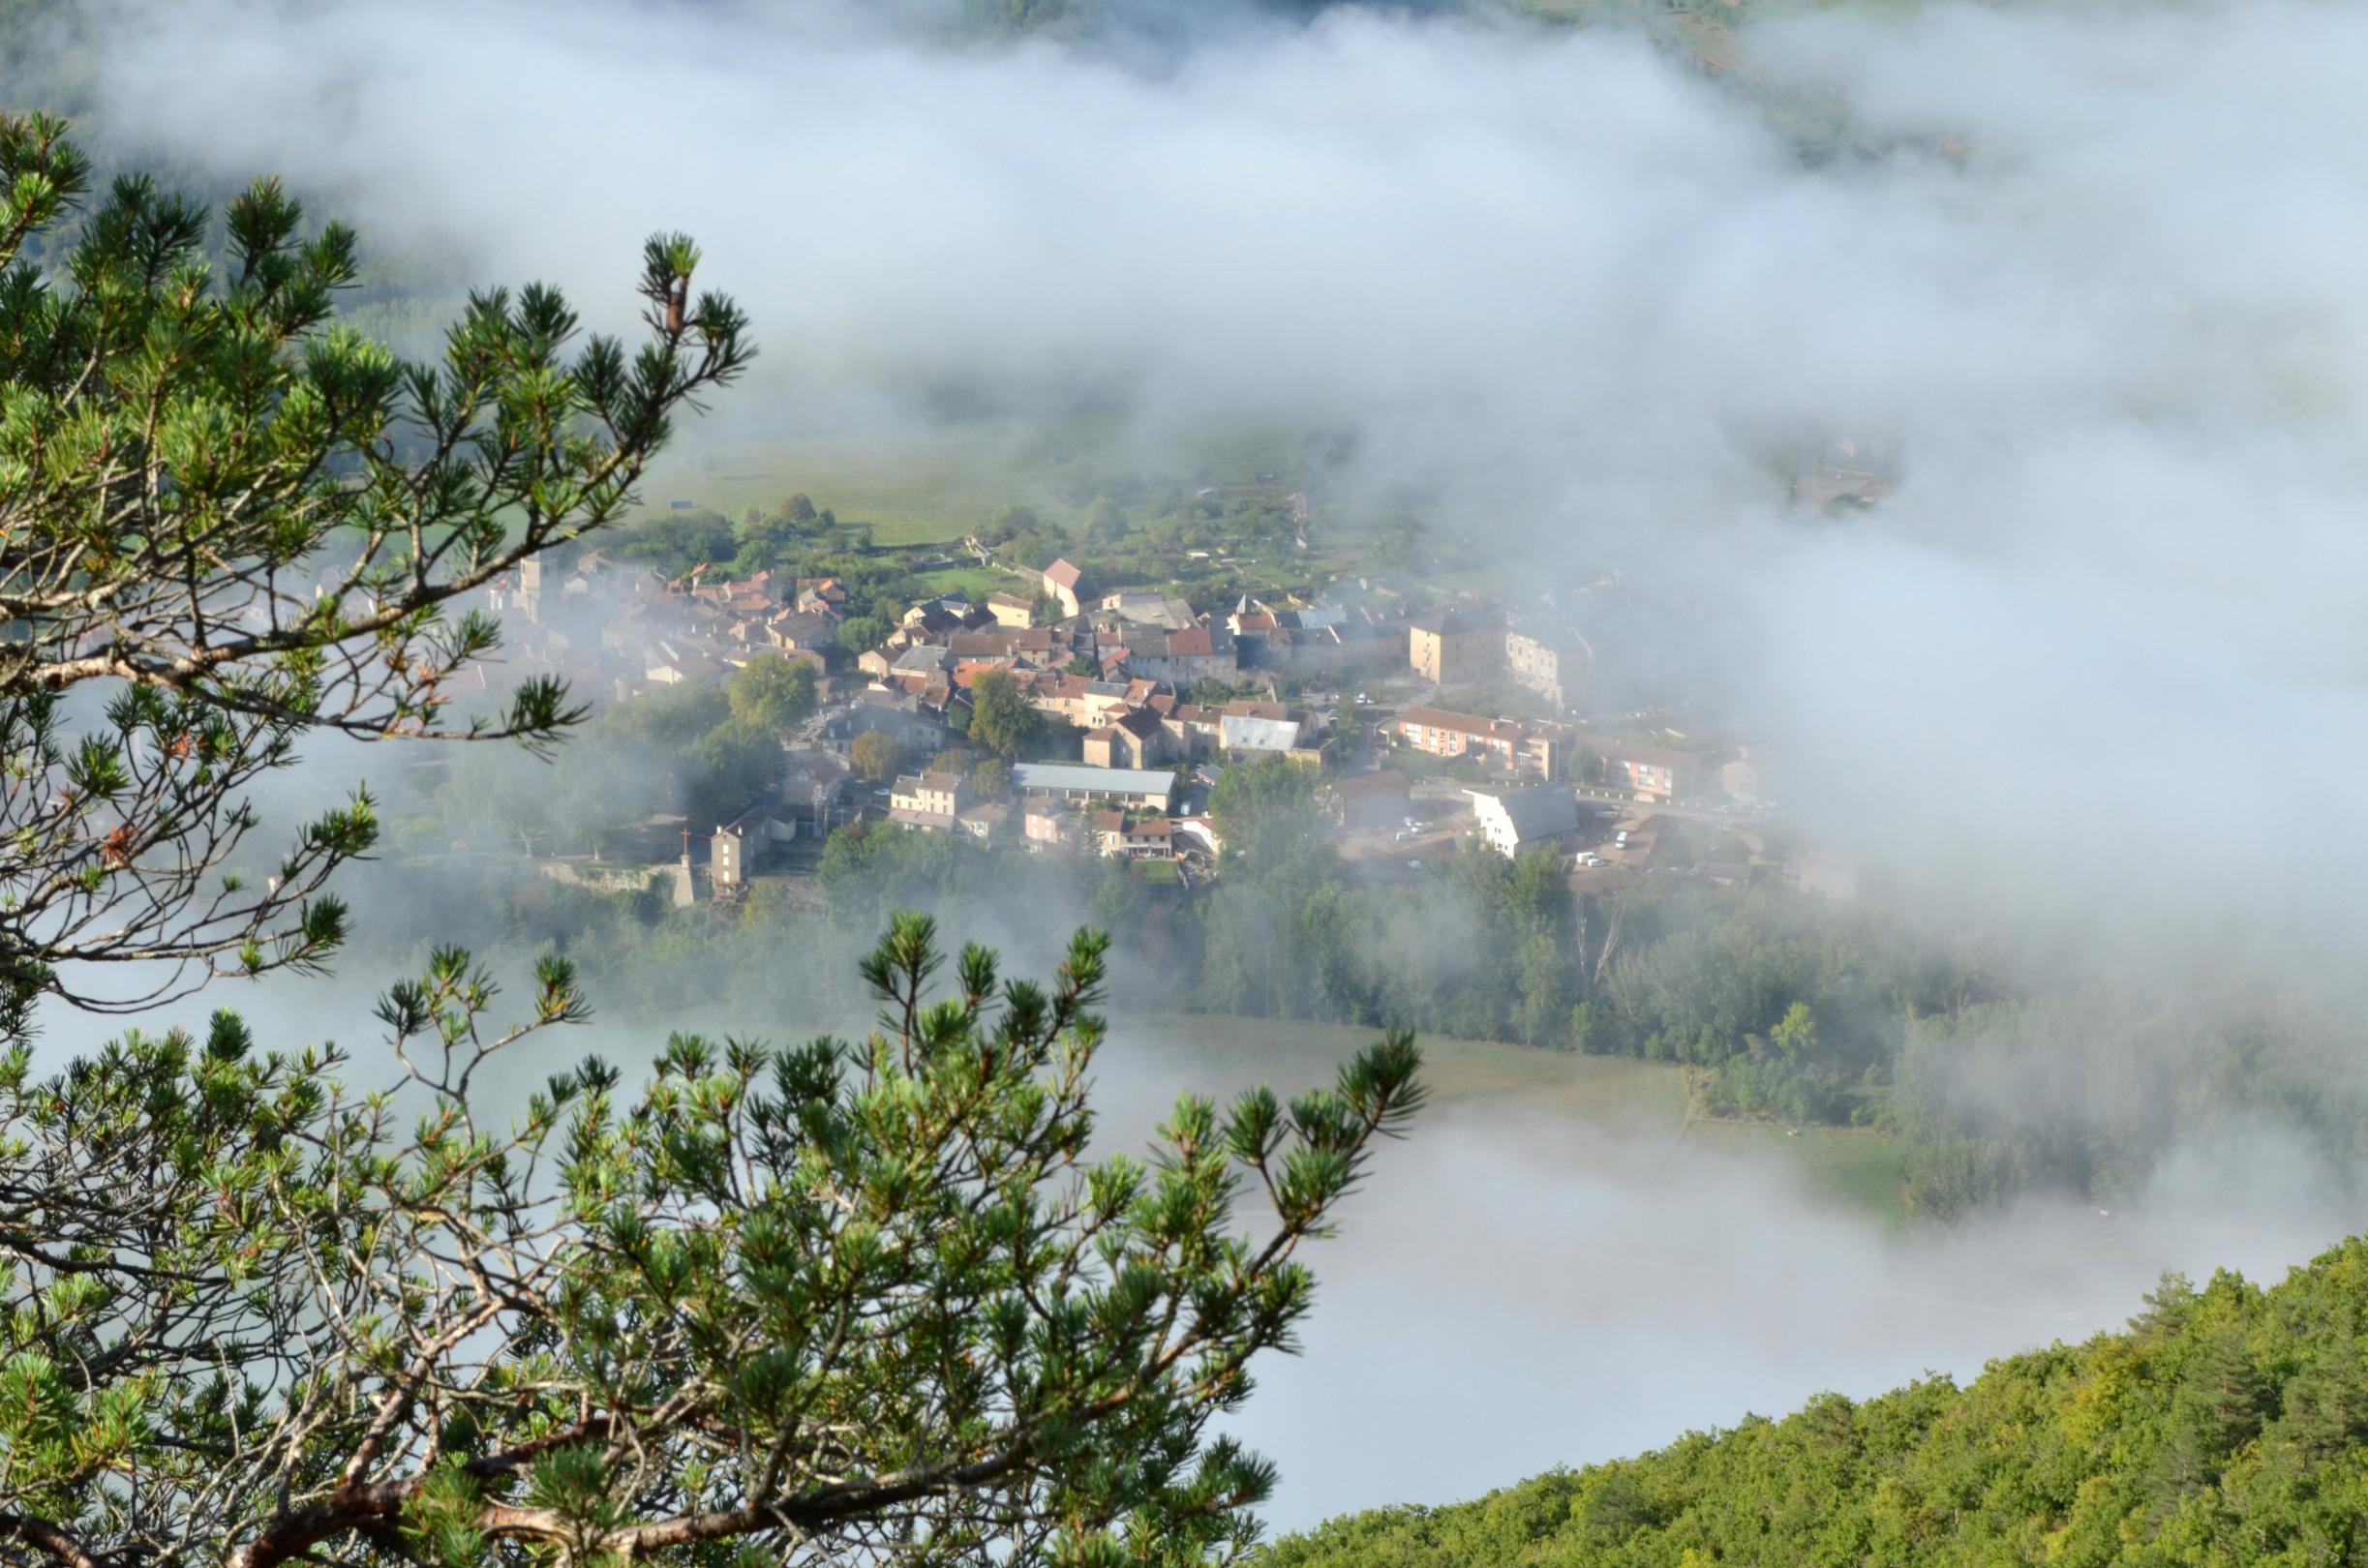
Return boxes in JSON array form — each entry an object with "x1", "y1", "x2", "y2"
[{"x1": 1243, "y1": 1106, "x2": 2358, "y2": 1530}]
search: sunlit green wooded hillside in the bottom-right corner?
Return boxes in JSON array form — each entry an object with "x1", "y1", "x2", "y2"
[{"x1": 1262, "y1": 1239, "x2": 2368, "y2": 1568}]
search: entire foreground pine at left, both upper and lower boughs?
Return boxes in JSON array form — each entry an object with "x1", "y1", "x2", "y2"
[{"x1": 0, "y1": 116, "x2": 1421, "y2": 1568}]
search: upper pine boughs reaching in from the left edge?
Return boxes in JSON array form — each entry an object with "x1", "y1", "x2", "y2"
[{"x1": 0, "y1": 116, "x2": 753, "y2": 1035}]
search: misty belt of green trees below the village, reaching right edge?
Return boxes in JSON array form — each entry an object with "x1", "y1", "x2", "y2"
[{"x1": 388, "y1": 743, "x2": 2368, "y2": 1220}]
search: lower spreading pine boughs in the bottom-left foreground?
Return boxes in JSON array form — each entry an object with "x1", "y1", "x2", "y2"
[{"x1": 0, "y1": 915, "x2": 1421, "y2": 1568}]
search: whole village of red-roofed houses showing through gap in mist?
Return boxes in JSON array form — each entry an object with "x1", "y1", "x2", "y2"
[{"x1": 466, "y1": 498, "x2": 1854, "y2": 905}]
